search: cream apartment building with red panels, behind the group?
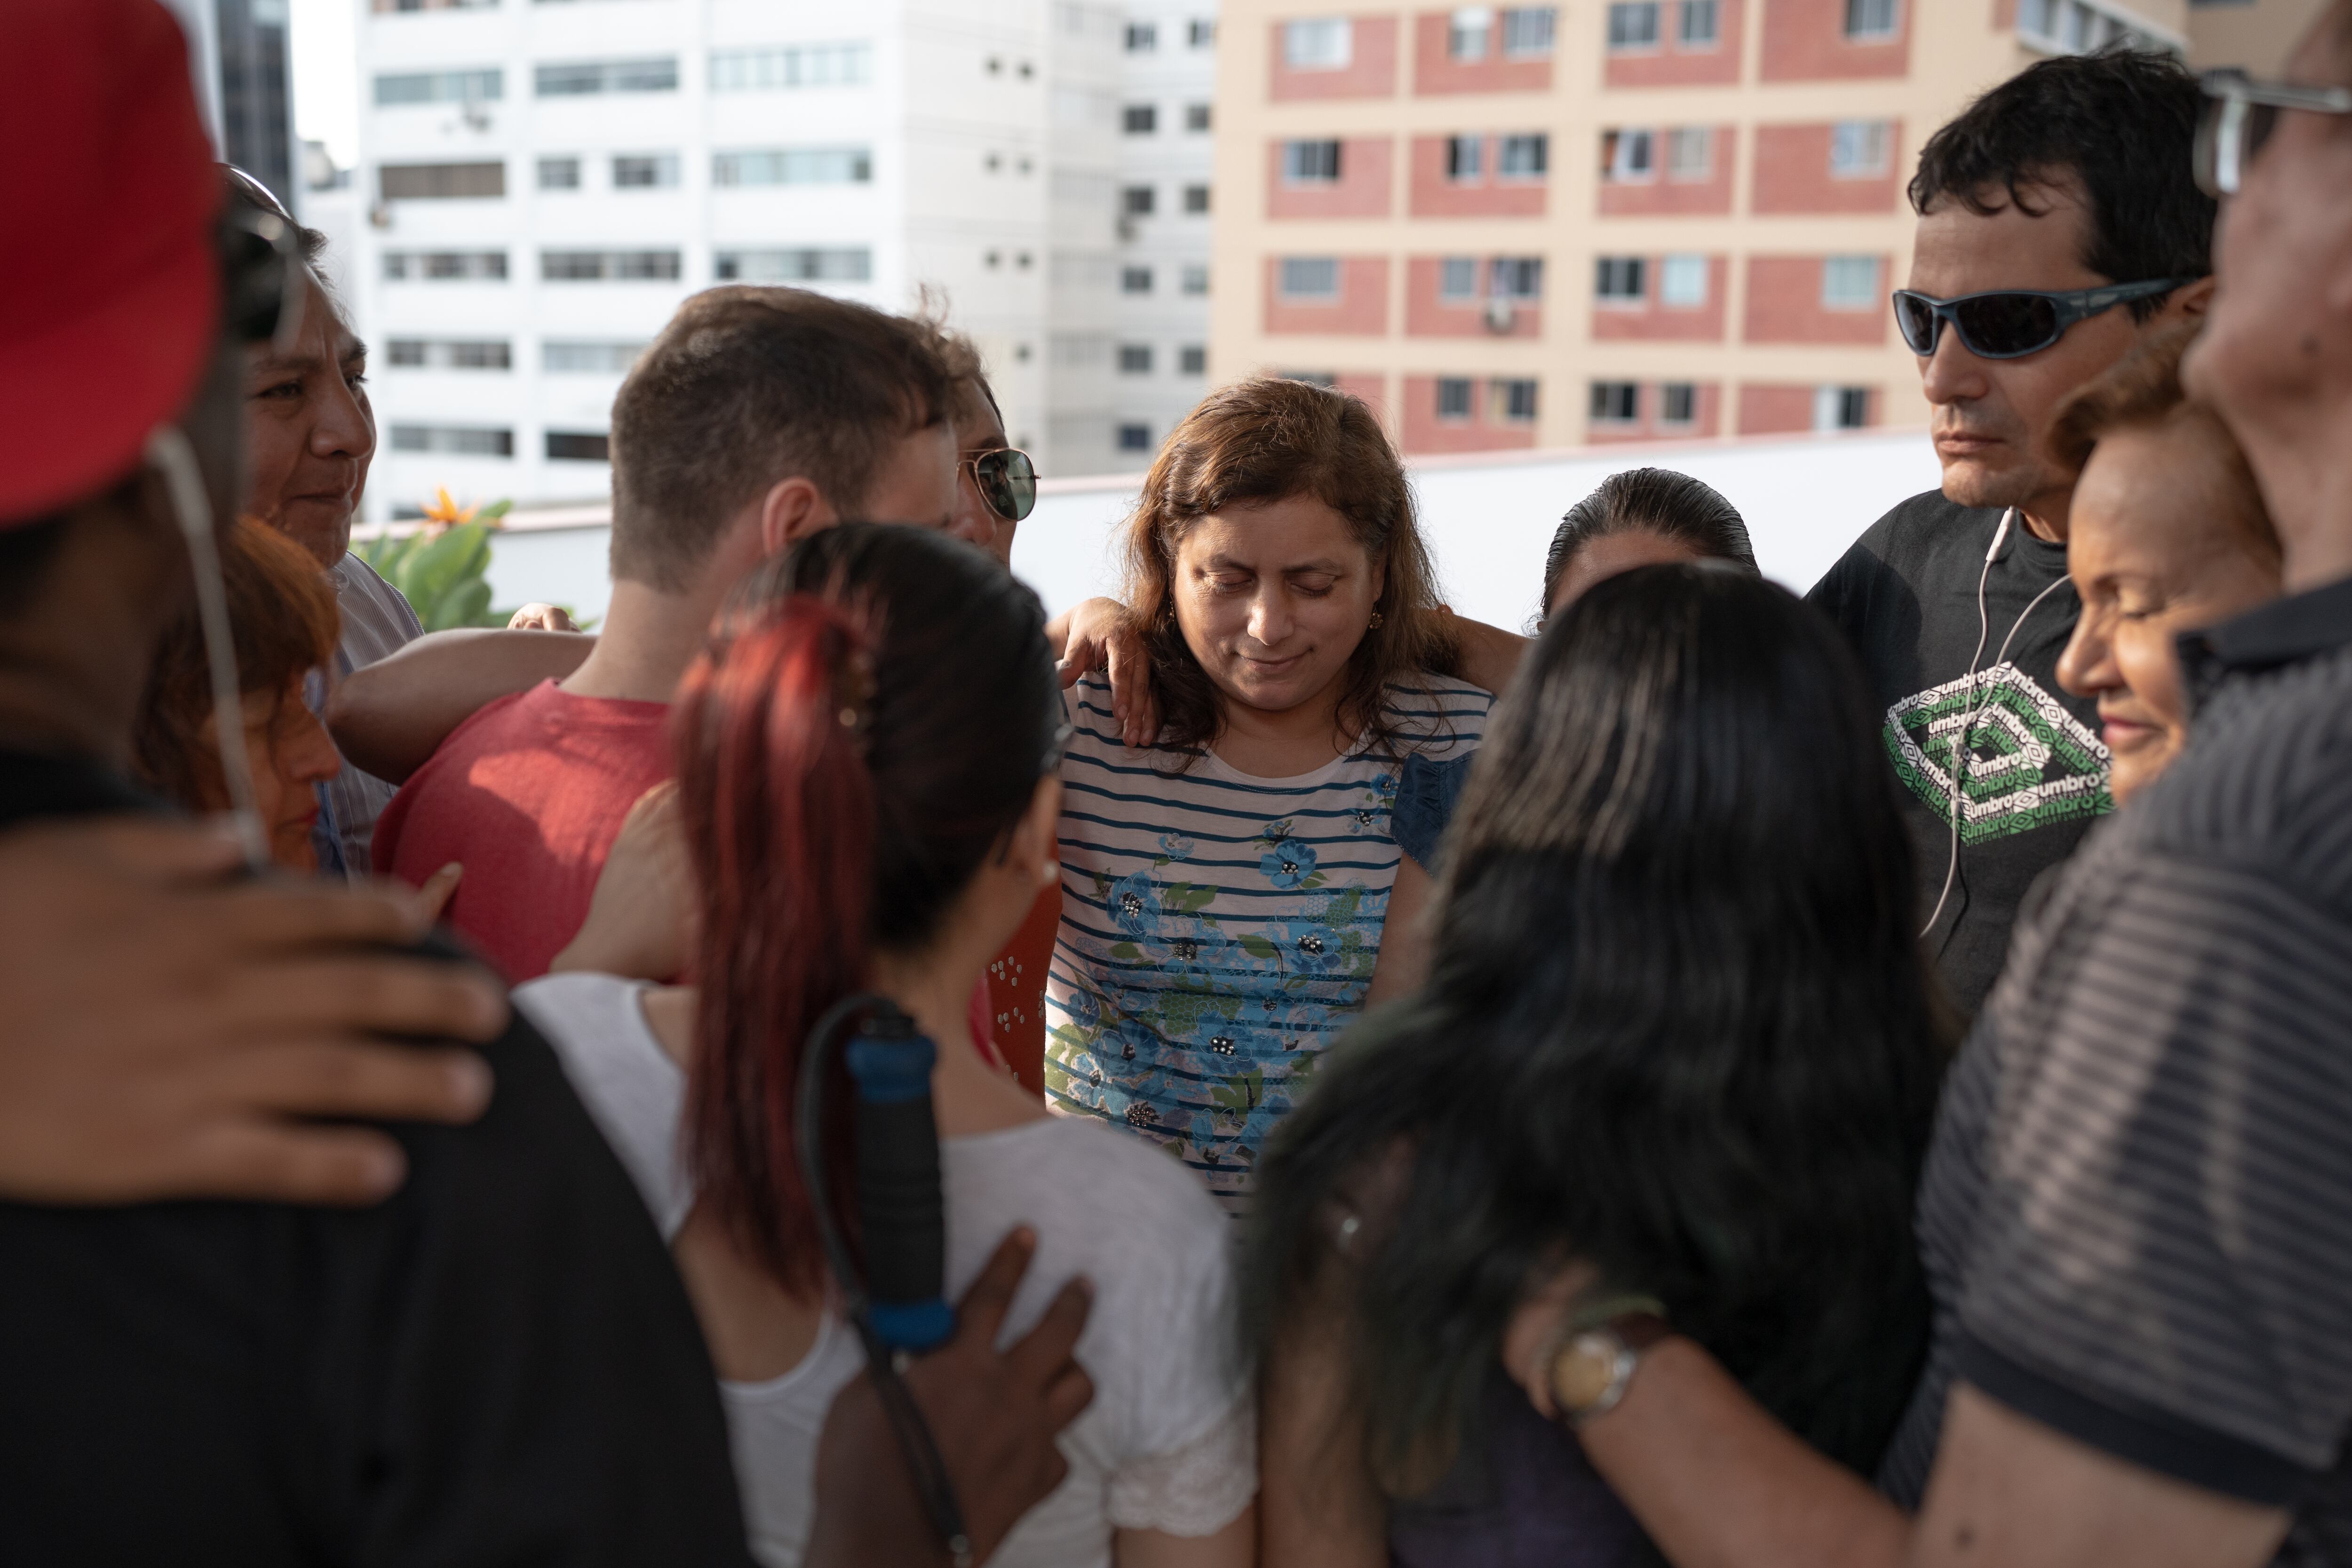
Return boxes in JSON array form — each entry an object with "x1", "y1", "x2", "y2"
[{"x1": 1211, "y1": 0, "x2": 2317, "y2": 454}]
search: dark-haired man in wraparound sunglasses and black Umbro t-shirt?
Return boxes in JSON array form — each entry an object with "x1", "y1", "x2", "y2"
[{"x1": 1809, "y1": 52, "x2": 2213, "y2": 1013}]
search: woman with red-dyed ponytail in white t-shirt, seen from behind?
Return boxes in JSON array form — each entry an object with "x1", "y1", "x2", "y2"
[{"x1": 515, "y1": 524, "x2": 1256, "y2": 1568}]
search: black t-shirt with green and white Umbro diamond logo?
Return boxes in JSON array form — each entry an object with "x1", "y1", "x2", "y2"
[{"x1": 1806, "y1": 491, "x2": 2114, "y2": 1013}]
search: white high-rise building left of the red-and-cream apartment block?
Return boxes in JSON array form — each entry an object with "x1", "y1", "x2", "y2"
[{"x1": 341, "y1": 0, "x2": 1214, "y2": 519}]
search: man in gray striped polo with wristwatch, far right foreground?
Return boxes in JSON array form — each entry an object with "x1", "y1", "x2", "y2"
[{"x1": 1505, "y1": 0, "x2": 2352, "y2": 1568}]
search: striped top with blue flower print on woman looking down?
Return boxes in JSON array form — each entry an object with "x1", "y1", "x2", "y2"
[{"x1": 1044, "y1": 677, "x2": 1494, "y2": 1213}]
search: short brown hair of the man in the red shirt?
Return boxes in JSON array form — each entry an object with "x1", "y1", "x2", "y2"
[{"x1": 612, "y1": 285, "x2": 950, "y2": 590}]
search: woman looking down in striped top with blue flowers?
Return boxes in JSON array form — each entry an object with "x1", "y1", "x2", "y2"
[{"x1": 1044, "y1": 381, "x2": 1491, "y2": 1213}]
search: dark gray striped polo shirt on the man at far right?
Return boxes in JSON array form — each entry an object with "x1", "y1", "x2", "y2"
[{"x1": 1879, "y1": 581, "x2": 2352, "y2": 1566}]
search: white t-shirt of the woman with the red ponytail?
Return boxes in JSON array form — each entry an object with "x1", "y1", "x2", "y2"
[{"x1": 515, "y1": 973, "x2": 1258, "y2": 1568}]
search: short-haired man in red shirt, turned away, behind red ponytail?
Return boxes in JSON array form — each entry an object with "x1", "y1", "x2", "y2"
[{"x1": 374, "y1": 287, "x2": 957, "y2": 985}]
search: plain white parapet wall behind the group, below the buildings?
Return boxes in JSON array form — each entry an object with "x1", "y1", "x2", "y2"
[{"x1": 459, "y1": 430, "x2": 1938, "y2": 628}]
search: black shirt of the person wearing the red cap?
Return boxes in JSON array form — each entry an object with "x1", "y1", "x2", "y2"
[{"x1": 0, "y1": 752, "x2": 750, "y2": 1568}]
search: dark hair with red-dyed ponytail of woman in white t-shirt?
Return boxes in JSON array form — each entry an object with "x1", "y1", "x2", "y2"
[{"x1": 673, "y1": 524, "x2": 1061, "y2": 1297}]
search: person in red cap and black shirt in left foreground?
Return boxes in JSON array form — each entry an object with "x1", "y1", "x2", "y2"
[{"x1": 0, "y1": 0, "x2": 1087, "y2": 1566}]
